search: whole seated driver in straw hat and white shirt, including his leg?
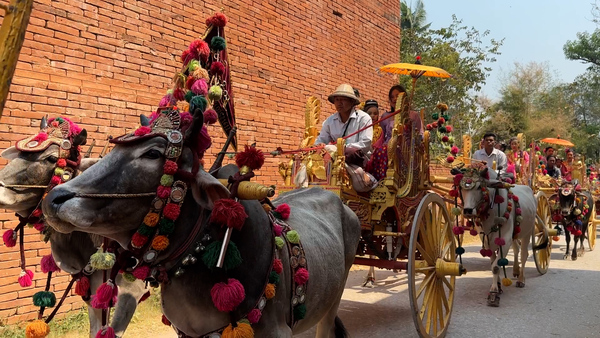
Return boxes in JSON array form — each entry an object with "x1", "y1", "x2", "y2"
[{"x1": 315, "y1": 84, "x2": 377, "y2": 192}]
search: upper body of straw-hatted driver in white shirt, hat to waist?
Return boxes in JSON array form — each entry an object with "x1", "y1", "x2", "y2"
[{"x1": 315, "y1": 84, "x2": 373, "y2": 166}]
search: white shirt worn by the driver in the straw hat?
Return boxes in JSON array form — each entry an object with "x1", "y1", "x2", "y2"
[{"x1": 315, "y1": 109, "x2": 373, "y2": 154}]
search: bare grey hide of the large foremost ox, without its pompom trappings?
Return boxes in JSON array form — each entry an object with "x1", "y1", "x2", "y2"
[{"x1": 43, "y1": 115, "x2": 360, "y2": 338}]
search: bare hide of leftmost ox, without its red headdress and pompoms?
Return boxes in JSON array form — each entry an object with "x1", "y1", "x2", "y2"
[{"x1": 0, "y1": 121, "x2": 147, "y2": 337}]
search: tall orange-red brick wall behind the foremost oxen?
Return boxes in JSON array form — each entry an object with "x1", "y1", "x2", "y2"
[{"x1": 0, "y1": 0, "x2": 400, "y2": 322}]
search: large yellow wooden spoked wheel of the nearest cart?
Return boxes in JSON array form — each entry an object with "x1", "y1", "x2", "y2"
[{"x1": 408, "y1": 193, "x2": 464, "y2": 337}]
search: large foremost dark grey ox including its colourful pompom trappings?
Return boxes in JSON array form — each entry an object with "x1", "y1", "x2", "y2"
[{"x1": 43, "y1": 107, "x2": 360, "y2": 337}]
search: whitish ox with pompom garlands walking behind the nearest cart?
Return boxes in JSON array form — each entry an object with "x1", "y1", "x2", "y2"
[{"x1": 455, "y1": 167, "x2": 537, "y2": 306}]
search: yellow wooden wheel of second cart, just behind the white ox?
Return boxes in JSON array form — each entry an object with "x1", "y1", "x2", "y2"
[{"x1": 531, "y1": 191, "x2": 552, "y2": 275}]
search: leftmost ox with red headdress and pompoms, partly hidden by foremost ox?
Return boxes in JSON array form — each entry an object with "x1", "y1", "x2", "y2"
[{"x1": 0, "y1": 118, "x2": 147, "y2": 337}]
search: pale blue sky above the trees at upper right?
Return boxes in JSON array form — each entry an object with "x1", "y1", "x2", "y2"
[{"x1": 424, "y1": 0, "x2": 596, "y2": 99}]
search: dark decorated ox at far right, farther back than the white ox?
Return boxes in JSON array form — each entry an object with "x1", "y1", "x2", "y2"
[{"x1": 555, "y1": 180, "x2": 595, "y2": 260}]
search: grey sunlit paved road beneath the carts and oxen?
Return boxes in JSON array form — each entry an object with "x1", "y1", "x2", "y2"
[{"x1": 298, "y1": 231, "x2": 600, "y2": 338}]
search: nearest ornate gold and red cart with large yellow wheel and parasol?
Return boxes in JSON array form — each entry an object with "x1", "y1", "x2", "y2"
[{"x1": 275, "y1": 64, "x2": 466, "y2": 337}]
